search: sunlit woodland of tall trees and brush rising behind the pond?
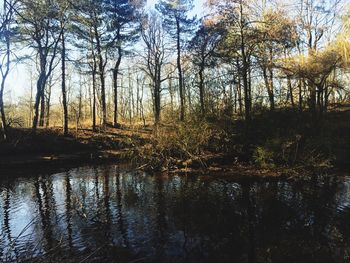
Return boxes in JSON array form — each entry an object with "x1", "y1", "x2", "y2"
[{"x1": 0, "y1": 0, "x2": 350, "y2": 174}]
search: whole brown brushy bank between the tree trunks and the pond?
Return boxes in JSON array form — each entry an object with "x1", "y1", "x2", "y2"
[{"x1": 0, "y1": 110, "x2": 350, "y2": 178}]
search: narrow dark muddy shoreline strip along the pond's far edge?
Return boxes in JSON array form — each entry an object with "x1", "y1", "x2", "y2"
[{"x1": 0, "y1": 149, "x2": 348, "y2": 184}]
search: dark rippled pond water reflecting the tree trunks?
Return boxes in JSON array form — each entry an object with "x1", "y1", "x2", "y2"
[{"x1": 0, "y1": 165, "x2": 350, "y2": 262}]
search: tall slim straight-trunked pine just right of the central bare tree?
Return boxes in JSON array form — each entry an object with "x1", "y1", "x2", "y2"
[{"x1": 156, "y1": 0, "x2": 196, "y2": 121}]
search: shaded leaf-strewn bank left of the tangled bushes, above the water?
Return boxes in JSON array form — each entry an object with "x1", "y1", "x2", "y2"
[{"x1": 0, "y1": 126, "x2": 147, "y2": 169}]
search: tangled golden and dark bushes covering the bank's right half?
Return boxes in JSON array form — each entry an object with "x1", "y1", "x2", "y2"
[{"x1": 133, "y1": 110, "x2": 349, "y2": 174}]
